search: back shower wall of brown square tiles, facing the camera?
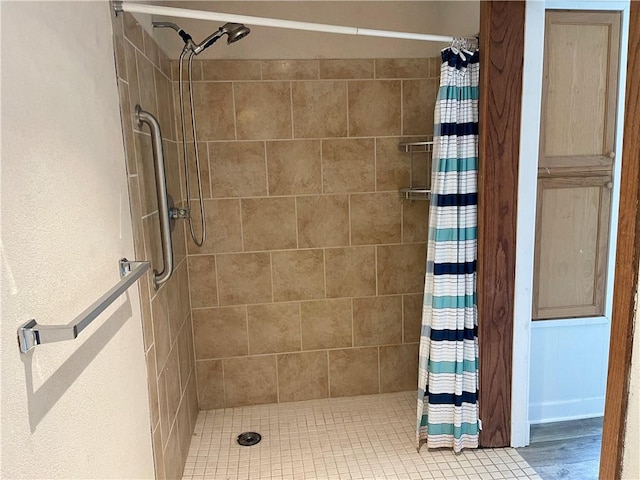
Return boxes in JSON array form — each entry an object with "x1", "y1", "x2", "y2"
[{"x1": 172, "y1": 59, "x2": 440, "y2": 409}]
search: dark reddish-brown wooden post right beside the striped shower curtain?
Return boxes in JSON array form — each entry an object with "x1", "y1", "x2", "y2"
[{"x1": 478, "y1": 1, "x2": 525, "y2": 447}]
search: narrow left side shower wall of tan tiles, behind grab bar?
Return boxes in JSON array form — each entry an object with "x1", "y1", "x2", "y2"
[{"x1": 113, "y1": 13, "x2": 198, "y2": 479}]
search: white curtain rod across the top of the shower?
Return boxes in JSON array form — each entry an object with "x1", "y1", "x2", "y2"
[{"x1": 113, "y1": 0, "x2": 454, "y2": 43}]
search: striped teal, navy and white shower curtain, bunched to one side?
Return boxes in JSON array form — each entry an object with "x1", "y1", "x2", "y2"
[{"x1": 417, "y1": 43, "x2": 480, "y2": 452}]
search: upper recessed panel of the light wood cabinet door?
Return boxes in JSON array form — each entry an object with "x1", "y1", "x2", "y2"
[{"x1": 540, "y1": 11, "x2": 620, "y2": 167}]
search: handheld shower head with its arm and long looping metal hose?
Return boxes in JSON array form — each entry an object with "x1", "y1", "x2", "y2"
[{"x1": 153, "y1": 22, "x2": 251, "y2": 247}]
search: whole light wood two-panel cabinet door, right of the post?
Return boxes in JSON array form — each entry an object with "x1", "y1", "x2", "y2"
[{"x1": 533, "y1": 11, "x2": 620, "y2": 320}]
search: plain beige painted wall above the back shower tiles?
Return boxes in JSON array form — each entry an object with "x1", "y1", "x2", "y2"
[{"x1": 154, "y1": 0, "x2": 480, "y2": 59}]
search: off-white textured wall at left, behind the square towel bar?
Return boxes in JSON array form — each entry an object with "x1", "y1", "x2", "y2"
[{"x1": 0, "y1": 1, "x2": 154, "y2": 479}]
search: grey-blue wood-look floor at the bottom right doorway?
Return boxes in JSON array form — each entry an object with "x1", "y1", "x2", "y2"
[{"x1": 518, "y1": 417, "x2": 602, "y2": 480}]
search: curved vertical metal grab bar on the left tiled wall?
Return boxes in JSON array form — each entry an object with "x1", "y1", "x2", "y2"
[{"x1": 135, "y1": 105, "x2": 173, "y2": 289}]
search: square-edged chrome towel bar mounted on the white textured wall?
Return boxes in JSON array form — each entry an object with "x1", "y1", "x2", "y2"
[{"x1": 18, "y1": 258, "x2": 150, "y2": 353}]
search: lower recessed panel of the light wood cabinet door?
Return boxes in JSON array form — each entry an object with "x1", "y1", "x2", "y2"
[{"x1": 533, "y1": 176, "x2": 611, "y2": 319}]
